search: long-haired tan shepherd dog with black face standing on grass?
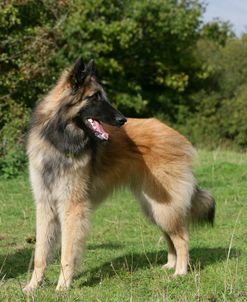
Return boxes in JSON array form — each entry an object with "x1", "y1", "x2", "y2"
[{"x1": 24, "y1": 58, "x2": 215, "y2": 292}]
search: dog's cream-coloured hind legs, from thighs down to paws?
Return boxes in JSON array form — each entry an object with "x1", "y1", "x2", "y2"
[{"x1": 135, "y1": 175, "x2": 194, "y2": 275}]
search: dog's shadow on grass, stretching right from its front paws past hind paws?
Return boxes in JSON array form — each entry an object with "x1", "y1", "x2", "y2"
[{"x1": 77, "y1": 247, "x2": 240, "y2": 286}]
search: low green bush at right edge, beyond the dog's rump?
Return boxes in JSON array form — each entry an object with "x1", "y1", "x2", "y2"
[{"x1": 176, "y1": 86, "x2": 247, "y2": 150}]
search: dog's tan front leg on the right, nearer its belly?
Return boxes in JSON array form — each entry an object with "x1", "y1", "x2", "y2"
[{"x1": 56, "y1": 200, "x2": 90, "y2": 290}]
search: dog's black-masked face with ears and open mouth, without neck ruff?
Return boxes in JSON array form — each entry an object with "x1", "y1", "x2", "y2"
[{"x1": 68, "y1": 58, "x2": 127, "y2": 141}]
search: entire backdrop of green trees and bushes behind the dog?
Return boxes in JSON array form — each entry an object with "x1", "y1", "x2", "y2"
[{"x1": 0, "y1": 0, "x2": 247, "y2": 177}]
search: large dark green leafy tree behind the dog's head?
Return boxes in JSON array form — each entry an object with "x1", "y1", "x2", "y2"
[{"x1": 0, "y1": 0, "x2": 205, "y2": 175}]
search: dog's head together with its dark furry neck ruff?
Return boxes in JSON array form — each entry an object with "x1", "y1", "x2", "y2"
[{"x1": 36, "y1": 58, "x2": 127, "y2": 155}]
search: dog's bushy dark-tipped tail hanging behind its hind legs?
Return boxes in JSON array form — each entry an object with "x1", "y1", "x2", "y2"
[{"x1": 191, "y1": 188, "x2": 215, "y2": 225}]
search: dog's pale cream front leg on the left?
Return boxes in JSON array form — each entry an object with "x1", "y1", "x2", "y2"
[{"x1": 23, "y1": 200, "x2": 59, "y2": 293}]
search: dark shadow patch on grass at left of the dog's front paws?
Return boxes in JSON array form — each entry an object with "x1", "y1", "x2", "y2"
[{"x1": 0, "y1": 248, "x2": 33, "y2": 280}]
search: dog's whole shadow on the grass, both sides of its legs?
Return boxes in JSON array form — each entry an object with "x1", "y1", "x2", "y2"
[{"x1": 0, "y1": 243, "x2": 240, "y2": 286}]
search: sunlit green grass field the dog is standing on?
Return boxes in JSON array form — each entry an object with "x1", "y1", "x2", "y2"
[{"x1": 0, "y1": 151, "x2": 247, "y2": 302}]
